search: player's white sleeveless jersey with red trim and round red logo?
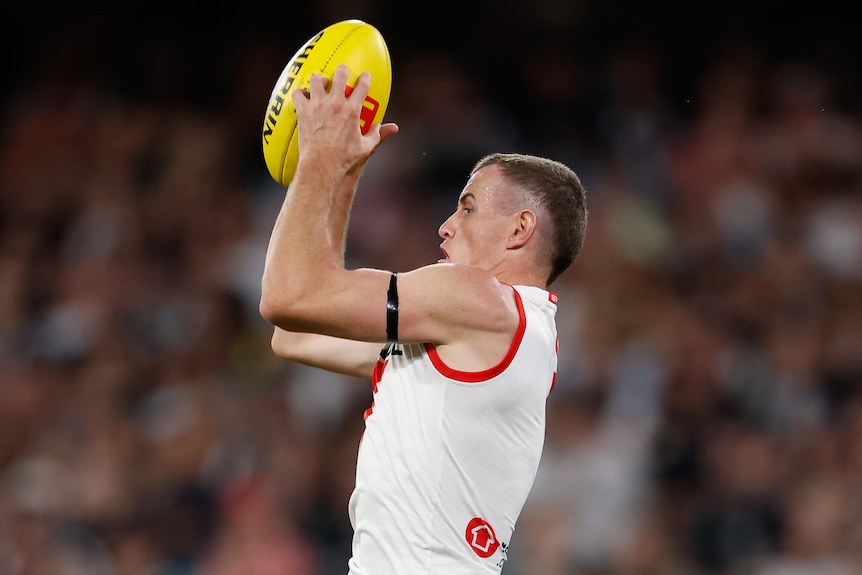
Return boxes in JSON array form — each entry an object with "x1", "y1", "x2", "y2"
[{"x1": 349, "y1": 286, "x2": 558, "y2": 575}]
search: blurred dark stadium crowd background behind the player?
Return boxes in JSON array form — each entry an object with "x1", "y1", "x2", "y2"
[{"x1": 0, "y1": 0, "x2": 862, "y2": 575}]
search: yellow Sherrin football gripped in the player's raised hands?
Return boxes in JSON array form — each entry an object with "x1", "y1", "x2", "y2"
[{"x1": 263, "y1": 20, "x2": 392, "y2": 186}]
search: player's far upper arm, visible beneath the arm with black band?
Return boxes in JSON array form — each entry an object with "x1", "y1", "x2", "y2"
[{"x1": 271, "y1": 327, "x2": 383, "y2": 378}]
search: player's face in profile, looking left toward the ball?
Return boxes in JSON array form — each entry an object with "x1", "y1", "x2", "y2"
[{"x1": 437, "y1": 166, "x2": 508, "y2": 270}]
